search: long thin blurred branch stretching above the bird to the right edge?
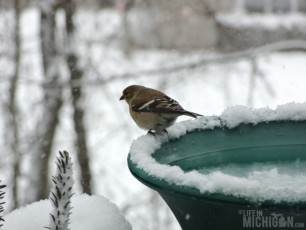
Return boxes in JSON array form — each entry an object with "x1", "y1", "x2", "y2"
[{"x1": 8, "y1": 40, "x2": 306, "y2": 88}]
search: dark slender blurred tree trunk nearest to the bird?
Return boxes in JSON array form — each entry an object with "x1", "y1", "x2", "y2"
[{"x1": 64, "y1": 0, "x2": 92, "y2": 194}]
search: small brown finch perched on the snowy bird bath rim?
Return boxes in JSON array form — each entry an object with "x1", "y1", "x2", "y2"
[{"x1": 119, "y1": 85, "x2": 203, "y2": 135}]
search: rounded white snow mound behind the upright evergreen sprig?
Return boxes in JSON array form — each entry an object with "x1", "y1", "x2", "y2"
[{"x1": 3, "y1": 194, "x2": 132, "y2": 230}]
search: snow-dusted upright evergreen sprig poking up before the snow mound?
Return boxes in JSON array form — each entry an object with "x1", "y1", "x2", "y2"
[{"x1": 47, "y1": 151, "x2": 74, "y2": 230}]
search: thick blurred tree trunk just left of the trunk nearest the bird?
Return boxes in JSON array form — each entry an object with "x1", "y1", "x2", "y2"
[{"x1": 30, "y1": 0, "x2": 62, "y2": 201}]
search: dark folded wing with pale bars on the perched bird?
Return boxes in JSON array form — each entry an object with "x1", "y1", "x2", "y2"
[{"x1": 131, "y1": 96, "x2": 185, "y2": 113}]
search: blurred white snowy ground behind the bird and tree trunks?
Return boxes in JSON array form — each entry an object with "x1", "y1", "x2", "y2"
[{"x1": 0, "y1": 1, "x2": 306, "y2": 230}]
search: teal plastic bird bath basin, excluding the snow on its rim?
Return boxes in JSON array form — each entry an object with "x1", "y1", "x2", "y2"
[{"x1": 128, "y1": 121, "x2": 306, "y2": 230}]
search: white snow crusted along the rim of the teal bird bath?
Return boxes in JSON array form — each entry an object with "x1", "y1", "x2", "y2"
[{"x1": 130, "y1": 103, "x2": 306, "y2": 202}]
